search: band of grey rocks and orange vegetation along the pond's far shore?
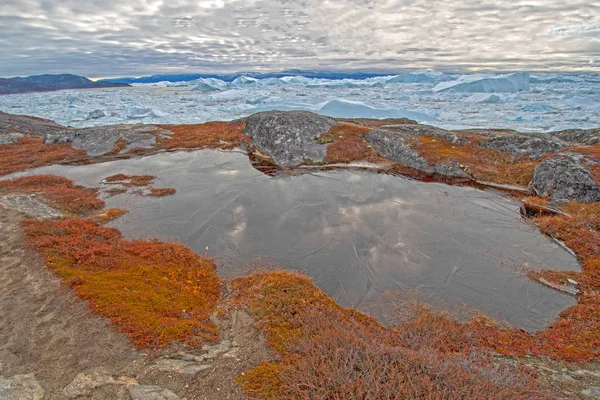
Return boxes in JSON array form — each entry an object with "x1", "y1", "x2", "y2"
[{"x1": 0, "y1": 111, "x2": 600, "y2": 203}]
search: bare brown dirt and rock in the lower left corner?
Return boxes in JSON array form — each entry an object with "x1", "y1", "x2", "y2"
[{"x1": 0, "y1": 205, "x2": 271, "y2": 400}]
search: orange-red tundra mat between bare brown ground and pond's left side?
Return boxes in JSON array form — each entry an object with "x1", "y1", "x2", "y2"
[{"x1": 25, "y1": 218, "x2": 221, "y2": 348}]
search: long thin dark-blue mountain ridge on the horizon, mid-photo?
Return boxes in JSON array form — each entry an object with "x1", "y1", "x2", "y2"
[{"x1": 100, "y1": 69, "x2": 390, "y2": 84}]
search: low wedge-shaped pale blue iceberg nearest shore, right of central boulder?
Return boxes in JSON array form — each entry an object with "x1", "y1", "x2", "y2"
[{"x1": 317, "y1": 100, "x2": 436, "y2": 121}]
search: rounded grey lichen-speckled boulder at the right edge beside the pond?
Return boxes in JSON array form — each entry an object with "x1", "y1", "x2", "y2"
[{"x1": 533, "y1": 153, "x2": 600, "y2": 203}]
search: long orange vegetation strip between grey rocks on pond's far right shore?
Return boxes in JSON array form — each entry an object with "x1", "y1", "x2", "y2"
[{"x1": 415, "y1": 136, "x2": 540, "y2": 186}]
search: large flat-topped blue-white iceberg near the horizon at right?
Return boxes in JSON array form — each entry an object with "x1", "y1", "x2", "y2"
[{"x1": 433, "y1": 72, "x2": 530, "y2": 93}]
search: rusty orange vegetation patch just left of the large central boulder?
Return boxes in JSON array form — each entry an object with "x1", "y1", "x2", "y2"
[{"x1": 157, "y1": 122, "x2": 247, "y2": 150}]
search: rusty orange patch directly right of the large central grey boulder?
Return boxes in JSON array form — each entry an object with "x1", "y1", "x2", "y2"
[{"x1": 319, "y1": 124, "x2": 384, "y2": 164}]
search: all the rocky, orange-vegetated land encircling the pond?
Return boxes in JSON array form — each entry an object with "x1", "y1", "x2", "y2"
[{"x1": 0, "y1": 112, "x2": 600, "y2": 400}]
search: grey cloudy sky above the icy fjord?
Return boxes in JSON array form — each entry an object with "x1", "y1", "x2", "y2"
[{"x1": 0, "y1": 0, "x2": 600, "y2": 77}]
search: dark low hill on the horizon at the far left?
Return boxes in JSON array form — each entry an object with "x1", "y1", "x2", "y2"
[{"x1": 0, "y1": 74, "x2": 129, "y2": 95}]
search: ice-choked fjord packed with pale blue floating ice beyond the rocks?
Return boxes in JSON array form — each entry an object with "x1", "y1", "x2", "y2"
[{"x1": 0, "y1": 72, "x2": 600, "y2": 132}]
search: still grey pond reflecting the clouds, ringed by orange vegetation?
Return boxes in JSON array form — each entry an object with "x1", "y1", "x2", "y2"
[{"x1": 22, "y1": 151, "x2": 577, "y2": 329}]
